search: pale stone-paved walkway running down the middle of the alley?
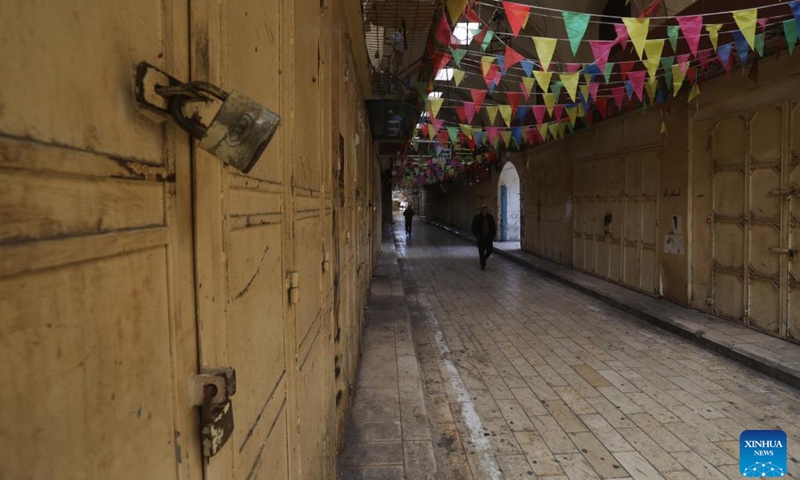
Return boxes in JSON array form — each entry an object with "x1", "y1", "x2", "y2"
[{"x1": 343, "y1": 218, "x2": 800, "y2": 480}]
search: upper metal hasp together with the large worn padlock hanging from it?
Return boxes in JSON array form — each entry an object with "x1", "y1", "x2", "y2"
[{"x1": 136, "y1": 62, "x2": 281, "y2": 173}]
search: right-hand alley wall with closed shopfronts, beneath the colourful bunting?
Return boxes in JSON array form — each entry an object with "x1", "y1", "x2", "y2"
[{"x1": 426, "y1": 53, "x2": 800, "y2": 340}]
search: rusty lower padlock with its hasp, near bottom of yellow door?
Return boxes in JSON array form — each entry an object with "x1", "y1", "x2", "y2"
[{"x1": 189, "y1": 368, "x2": 236, "y2": 458}]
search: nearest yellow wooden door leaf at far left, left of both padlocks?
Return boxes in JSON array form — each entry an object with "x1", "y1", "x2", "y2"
[{"x1": 0, "y1": 0, "x2": 202, "y2": 480}]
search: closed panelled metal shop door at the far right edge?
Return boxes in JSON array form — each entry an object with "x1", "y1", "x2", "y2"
[{"x1": 709, "y1": 102, "x2": 800, "y2": 341}]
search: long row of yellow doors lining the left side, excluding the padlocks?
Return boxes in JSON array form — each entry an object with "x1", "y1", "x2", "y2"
[{"x1": 0, "y1": 0, "x2": 381, "y2": 480}]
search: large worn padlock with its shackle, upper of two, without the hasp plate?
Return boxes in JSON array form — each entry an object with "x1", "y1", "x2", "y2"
[{"x1": 156, "y1": 82, "x2": 281, "y2": 173}]
